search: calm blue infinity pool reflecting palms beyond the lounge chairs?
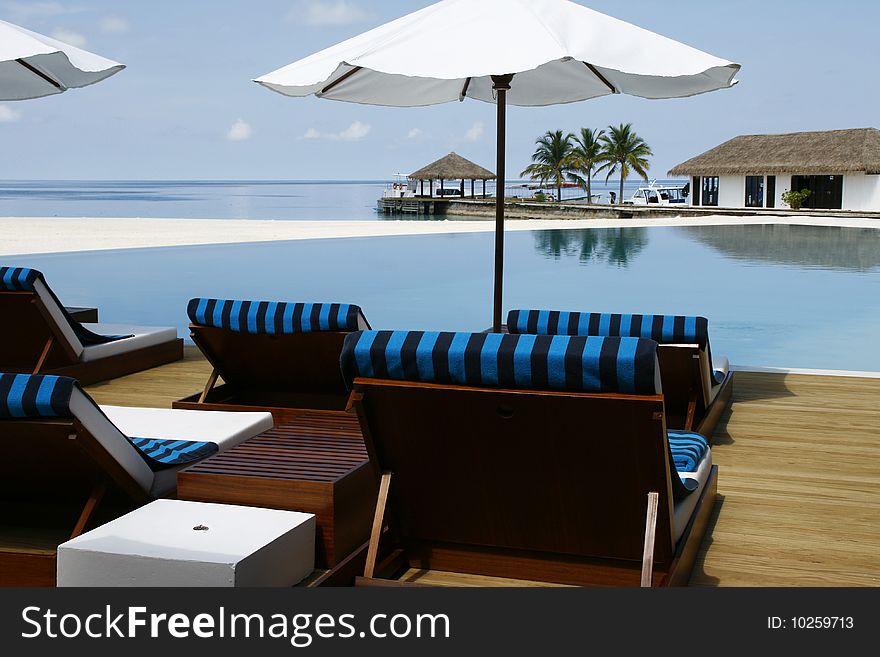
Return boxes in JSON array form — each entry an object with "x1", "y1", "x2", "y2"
[{"x1": 3, "y1": 226, "x2": 880, "y2": 371}]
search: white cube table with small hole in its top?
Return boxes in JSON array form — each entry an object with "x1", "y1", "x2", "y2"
[{"x1": 58, "y1": 500, "x2": 315, "y2": 587}]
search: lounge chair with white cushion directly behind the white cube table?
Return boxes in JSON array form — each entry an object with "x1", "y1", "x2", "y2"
[{"x1": 0, "y1": 374, "x2": 272, "y2": 586}]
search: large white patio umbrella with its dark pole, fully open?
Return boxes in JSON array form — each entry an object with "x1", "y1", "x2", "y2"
[{"x1": 255, "y1": 0, "x2": 740, "y2": 331}]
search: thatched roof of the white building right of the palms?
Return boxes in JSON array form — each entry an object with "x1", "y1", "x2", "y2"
[{"x1": 669, "y1": 128, "x2": 880, "y2": 176}]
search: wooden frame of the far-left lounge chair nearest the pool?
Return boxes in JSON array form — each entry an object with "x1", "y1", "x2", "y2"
[{"x1": 0, "y1": 291, "x2": 183, "y2": 385}]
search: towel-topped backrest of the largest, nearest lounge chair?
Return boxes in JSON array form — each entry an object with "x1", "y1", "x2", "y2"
[{"x1": 342, "y1": 332, "x2": 681, "y2": 563}]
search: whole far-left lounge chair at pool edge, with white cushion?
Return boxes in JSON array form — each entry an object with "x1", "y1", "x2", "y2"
[{"x1": 0, "y1": 267, "x2": 183, "y2": 385}]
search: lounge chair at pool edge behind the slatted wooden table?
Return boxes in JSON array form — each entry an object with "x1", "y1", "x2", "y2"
[{"x1": 173, "y1": 298, "x2": 370, "y2": 424}]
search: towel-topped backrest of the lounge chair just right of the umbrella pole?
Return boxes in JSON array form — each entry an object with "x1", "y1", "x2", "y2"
[{"x1": 507, "y1": 310, "x2": 715, "y2": 417}]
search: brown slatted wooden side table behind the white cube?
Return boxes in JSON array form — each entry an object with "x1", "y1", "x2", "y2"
[{"x1": 177, "y1": 411, "x2": 378, "y2": 568}]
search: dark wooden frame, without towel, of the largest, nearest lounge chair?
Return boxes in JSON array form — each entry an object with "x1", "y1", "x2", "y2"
[{"x1": 340, "y1": 378, "x2": 717, "y2": 586}]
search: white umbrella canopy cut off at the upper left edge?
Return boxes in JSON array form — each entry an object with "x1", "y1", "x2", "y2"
[{"x1": 0, "y1": 20, "x2": 125, "y2": 100}]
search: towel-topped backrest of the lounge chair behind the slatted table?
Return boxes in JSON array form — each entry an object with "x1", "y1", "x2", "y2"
[{"x1": 187, "y1": 298, "x2": 369, "y2": 395}]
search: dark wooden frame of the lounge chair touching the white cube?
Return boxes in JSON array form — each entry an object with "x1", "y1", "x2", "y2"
[{"x1": 0, "y1": 412, "x2": 149, "y2": 586}]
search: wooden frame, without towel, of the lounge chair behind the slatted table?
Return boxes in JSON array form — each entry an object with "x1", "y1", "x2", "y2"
[{"x1": 172, "y1": 324, "x2": 348, "y2": 424}]
